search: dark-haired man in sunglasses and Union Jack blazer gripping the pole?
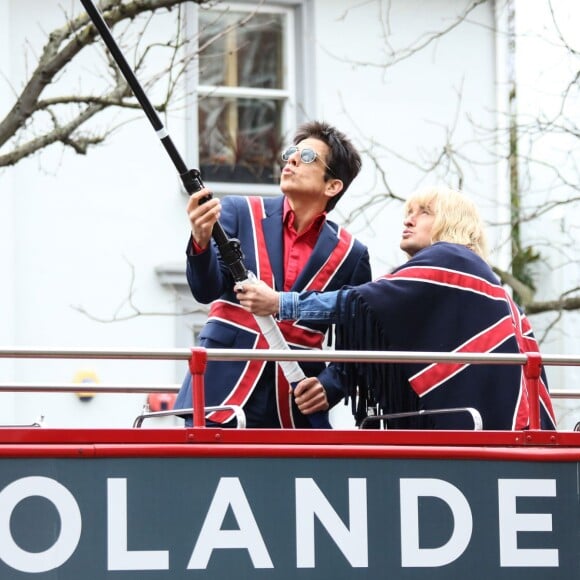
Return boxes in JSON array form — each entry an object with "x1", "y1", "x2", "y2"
[{"x1": 175, "y1": 122, "x2": 371, "y2": 428}]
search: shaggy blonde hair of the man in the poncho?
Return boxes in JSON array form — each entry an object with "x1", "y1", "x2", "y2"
[{"x1": 405, "y1": 186, "x2": 487, "y2": 260}]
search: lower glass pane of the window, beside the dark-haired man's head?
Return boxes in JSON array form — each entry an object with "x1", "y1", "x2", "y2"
[{"x1": 198, "y1": 97, "x2": 283, "y2": 183}]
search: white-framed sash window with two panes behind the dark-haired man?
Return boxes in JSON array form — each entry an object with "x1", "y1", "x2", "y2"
[{"x1": 188, "y1": 2, "x2": 310, "y2": 192}]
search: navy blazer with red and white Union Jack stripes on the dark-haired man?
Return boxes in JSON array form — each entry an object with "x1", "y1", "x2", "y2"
[{"x1": 175, "y1": 196, "x2": 371, "y2": 428}]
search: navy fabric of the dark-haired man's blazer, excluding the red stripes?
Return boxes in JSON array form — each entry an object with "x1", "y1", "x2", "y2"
[{"x1": 175, "y1": 196, "x2": 371, "y2": 427}]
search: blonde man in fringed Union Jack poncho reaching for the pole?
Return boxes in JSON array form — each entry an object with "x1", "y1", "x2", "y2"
[{"x1": 238, "y1": 187, "x2": 555, "y2": 429}]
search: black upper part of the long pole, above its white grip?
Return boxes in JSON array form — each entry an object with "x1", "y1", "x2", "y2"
[{"x1": 81, "y1": 0, "x2": 248, "y2": 282}]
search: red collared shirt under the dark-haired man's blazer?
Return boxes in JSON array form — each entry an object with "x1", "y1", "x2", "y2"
[{"x1": 282, "y1": 198, "x2": 326, "y2": 292}]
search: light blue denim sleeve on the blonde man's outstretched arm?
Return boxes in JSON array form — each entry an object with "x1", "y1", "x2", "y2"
[{"x1": 278, "y1": 290, "x2": 348, "y2": 324}]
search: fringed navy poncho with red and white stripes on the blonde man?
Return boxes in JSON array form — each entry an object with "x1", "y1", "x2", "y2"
[{"x1": 337, "y1": 242, "x2": 555, "y2": 430}]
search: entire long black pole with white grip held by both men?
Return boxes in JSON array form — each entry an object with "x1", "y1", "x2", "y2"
[{"x1": 80, "y1": 0, "x2": 331, "y2": 429}]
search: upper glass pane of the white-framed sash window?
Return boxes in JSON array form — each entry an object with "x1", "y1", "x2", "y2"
[{"x1": 199, "y1": 11, "x2": 284, "y2": 89}]
